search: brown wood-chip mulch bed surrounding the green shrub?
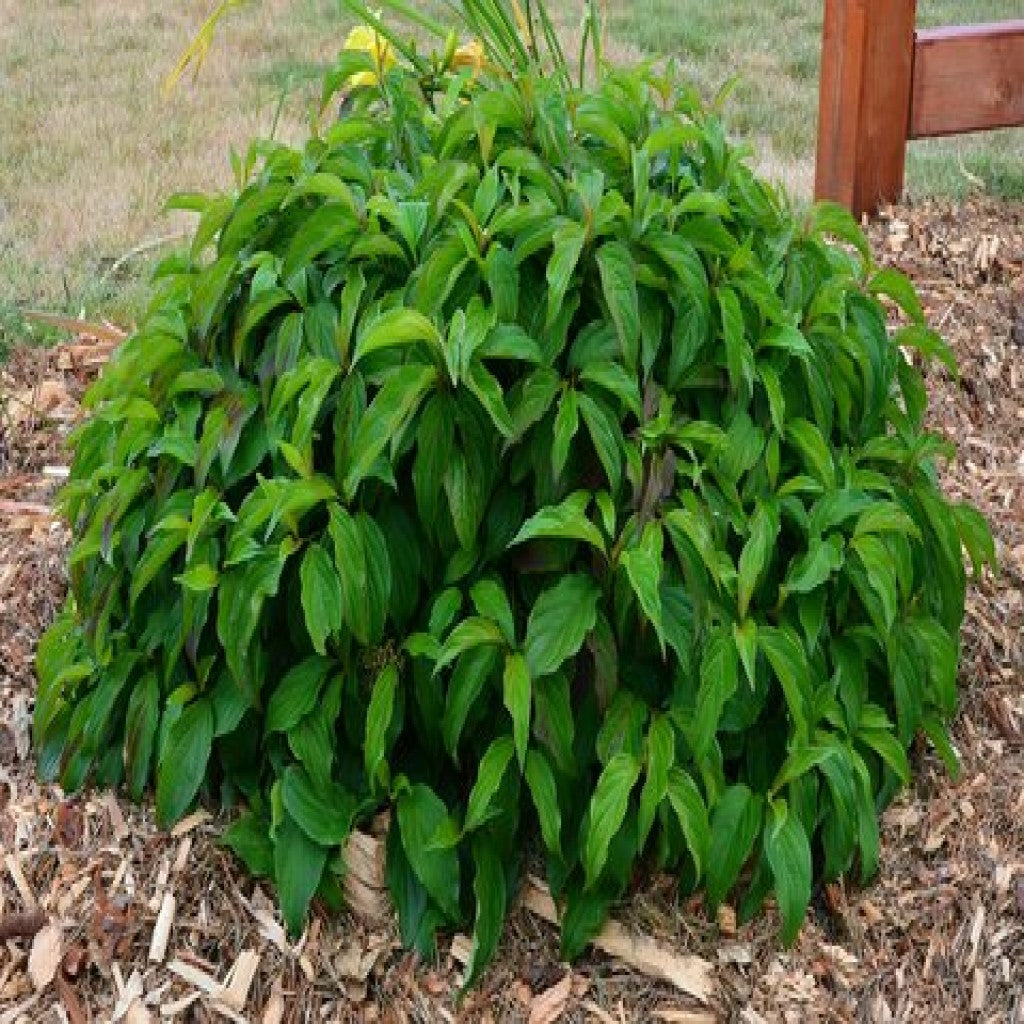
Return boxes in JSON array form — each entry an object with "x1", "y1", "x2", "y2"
[{"x1": 0, "y1": 202, "x2": 1024, "y2": 1024}]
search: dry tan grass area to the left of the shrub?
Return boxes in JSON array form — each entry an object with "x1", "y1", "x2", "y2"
[{"x1": 0, "y1": 0, "x2": 342, "y2": 343}]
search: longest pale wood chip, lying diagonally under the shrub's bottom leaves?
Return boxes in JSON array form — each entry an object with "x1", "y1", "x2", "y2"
[{"x1": 522, "y1": 878, "x2": 715, "y2": 1002}]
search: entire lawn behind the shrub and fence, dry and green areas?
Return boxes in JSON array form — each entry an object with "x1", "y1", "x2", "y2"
[{"x1": 0, "y1": 0, "x2": 1024, "y2": 348}]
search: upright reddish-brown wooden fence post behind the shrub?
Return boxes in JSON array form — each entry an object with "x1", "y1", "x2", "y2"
[{"x1": 815, "y1": 0, "x2": 916, "y2": 216}]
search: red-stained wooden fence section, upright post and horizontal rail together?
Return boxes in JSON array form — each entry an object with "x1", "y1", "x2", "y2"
[{"x1": 815, "y1": 0, "x2": 1024, "y2": 215}]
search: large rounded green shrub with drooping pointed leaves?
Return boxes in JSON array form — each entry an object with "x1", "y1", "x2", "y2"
[{"x1": 35, "y1": 3, "x2": 993, "y2": 977}]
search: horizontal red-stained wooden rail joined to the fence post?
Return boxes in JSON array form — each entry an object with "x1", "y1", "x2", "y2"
[{"x1": 907, "y1": 19, "x2": 1024, "y2": 138}]
